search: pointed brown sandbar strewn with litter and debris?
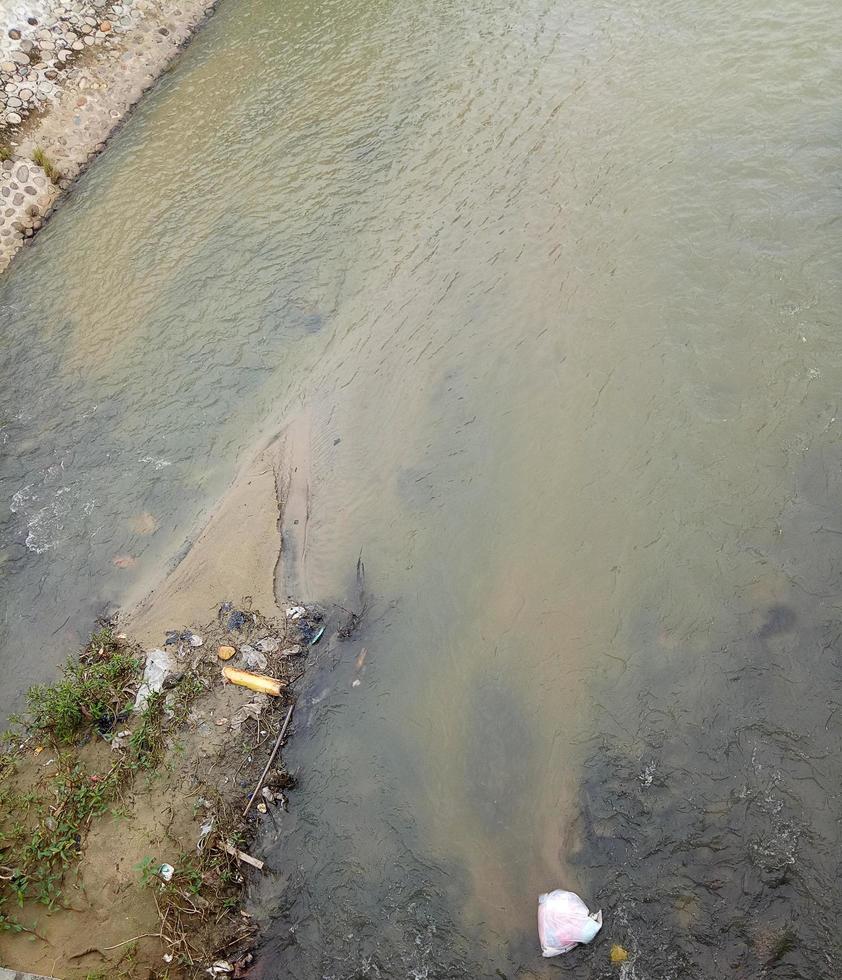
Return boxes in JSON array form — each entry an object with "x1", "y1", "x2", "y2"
[{"x1": 0, "y1": 423, "x2": 339, "y2": 980}]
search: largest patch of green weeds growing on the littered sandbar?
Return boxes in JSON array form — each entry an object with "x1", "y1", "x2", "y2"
[{"x1": 0, "y1": 626, "x2": 202, "y2": 931}]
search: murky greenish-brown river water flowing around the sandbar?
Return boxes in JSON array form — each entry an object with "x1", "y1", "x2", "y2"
[{"x1": 0, "y1": 0, "x2": 842, "y2": 980}]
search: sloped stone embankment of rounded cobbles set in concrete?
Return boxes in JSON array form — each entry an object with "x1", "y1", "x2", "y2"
[{"x1": 0, "y1": 0, "x2": 220, "y2": 272}]
